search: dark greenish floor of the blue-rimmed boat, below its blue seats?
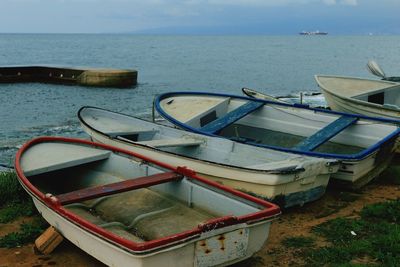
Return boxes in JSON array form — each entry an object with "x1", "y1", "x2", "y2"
[{"x1": 220, "y1": 124, "x2": 364, "y2": 154}]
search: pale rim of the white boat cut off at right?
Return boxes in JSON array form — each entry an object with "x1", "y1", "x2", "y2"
[{"x1": 314, "y1": 74, "x2": 400, "y2": 116}]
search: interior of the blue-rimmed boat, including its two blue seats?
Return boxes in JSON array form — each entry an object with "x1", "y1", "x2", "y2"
[{"x1": 161, "y1": 96, "x2": 397, "y2": 155}]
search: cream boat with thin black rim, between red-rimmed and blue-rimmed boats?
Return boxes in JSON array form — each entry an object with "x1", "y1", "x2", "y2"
[{"x1": 78, "y1": 107, "x2": 338, "y2": 207}]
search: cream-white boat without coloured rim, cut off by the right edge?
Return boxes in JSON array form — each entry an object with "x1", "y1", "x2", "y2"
[{"x1": 315, "y1": 75, "x2": 400, "y2": 119}]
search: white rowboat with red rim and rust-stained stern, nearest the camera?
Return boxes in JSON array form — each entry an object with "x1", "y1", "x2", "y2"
[{"x1": 15, "y1": 137, "x2": 280, "y2": 266}]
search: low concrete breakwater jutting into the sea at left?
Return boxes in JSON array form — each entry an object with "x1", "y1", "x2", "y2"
[{"x1": 0, "y1": 66, "x2": 137, "y2": 88}]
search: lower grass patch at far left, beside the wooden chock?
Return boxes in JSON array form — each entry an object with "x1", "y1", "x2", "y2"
[{"x1": 0, "y1": 217, "x2": 48, "y2": 248}]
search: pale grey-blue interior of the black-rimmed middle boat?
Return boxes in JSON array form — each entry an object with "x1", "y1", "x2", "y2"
[{"x1": 80, "y1": 108, "x2": 312, "y2": 173}]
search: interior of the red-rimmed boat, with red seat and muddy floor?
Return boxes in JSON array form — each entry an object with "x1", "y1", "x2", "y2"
[{"x1": 21, "y1": 143, "x2": 263, "y2": 245}]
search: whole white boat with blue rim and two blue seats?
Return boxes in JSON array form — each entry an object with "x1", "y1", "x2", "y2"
[{"x1": 155, "y1": 92, "x2": 400, "y2": 187}]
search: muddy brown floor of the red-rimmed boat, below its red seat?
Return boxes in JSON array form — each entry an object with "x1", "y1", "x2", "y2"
[{"x1": 65, "y1": 189, "x2": 216, "y2": 242}]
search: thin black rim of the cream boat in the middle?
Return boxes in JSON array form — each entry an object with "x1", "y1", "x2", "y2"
[{"x1": 78, "y1": 106, "x2": 318, "y2": 175}]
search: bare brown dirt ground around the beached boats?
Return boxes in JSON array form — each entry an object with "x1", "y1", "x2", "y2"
[{"x1": 0, "y1": 171, "x2": 400, "y2": 267}]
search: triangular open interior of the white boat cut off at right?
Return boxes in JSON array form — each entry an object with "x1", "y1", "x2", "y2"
[{"x1": 352, "y1": 86, "x2": 400, "y2": 110}]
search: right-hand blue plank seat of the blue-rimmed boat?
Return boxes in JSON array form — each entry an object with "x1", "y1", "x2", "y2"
[{"x1": 294, "y1": 115, "x2": 358, "y2": 151}]
